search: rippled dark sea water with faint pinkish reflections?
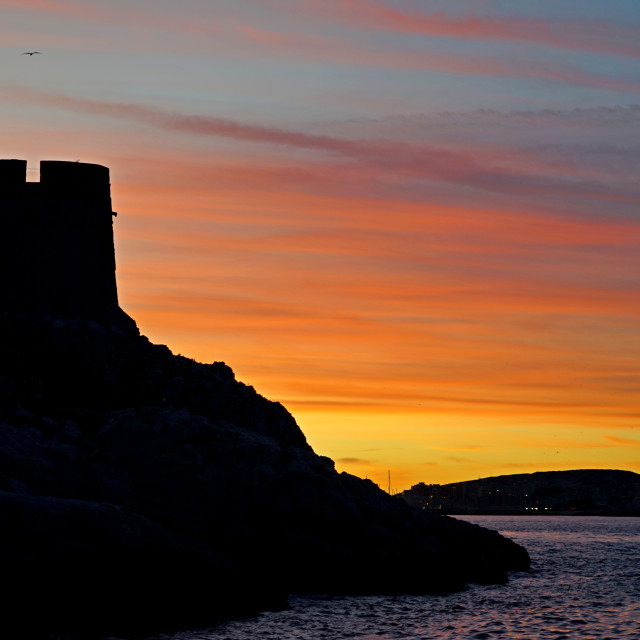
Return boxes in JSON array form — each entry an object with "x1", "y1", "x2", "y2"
[{"x1": 146, "y1": 516, "x2": 640, "y2": 640}]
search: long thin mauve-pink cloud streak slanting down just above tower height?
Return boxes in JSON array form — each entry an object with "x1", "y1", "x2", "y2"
[{"x1": 2, "y1": 87, "x2": 638, "y2": 208}]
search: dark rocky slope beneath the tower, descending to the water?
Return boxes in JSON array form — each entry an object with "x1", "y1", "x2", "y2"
[{"x1": 0, "y1": 313, "x2": 529, "y2": 637}]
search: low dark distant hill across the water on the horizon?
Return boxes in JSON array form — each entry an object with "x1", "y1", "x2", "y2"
[{"x1": 401, "y1": 469, "x2": 640, "y2": 516}]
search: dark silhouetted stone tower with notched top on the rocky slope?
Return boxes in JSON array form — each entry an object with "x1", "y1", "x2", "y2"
[{"x1": 0, "y1": 160, "x2": 127, "y2": 322}]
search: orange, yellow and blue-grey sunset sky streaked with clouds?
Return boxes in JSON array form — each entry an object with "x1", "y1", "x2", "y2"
[{"x1": 0, "y1": 0, "x2": 640, "y2": 491}]
